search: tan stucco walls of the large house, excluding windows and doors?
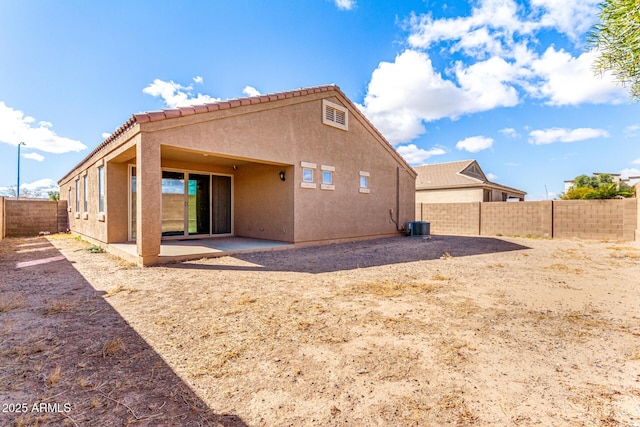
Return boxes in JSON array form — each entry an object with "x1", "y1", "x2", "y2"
[{"x1": 60, "y1": 86, "x2": 415, "y2": 263}]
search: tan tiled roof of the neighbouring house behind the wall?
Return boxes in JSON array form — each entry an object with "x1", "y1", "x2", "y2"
[{"x1": 414, "y1": 160, "x2": 527, "y2": 195}]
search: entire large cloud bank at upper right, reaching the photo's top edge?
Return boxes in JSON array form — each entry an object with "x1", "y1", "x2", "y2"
[{"x1": 361, "y1": 0, "x2": 629, "y2": 143}]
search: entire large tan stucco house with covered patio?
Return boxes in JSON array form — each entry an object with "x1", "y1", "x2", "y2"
[{"x1": 59, "y1": 85, "x2": 416, "y2": 265}]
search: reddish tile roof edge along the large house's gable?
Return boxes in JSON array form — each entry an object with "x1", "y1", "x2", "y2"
[{"x1": 60, "y1": 84, "x2": 416, "y2": 181}]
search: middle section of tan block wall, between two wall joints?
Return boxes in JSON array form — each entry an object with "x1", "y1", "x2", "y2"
[{"x1": 480, "y1": 200, "x2": 553, "y2": 237}]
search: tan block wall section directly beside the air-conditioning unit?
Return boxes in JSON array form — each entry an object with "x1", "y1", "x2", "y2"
[{"x1": 416, "y1": 202, "x2": 480, "y2": 235}]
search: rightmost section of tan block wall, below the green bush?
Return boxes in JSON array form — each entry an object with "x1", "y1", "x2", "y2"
[{"x1": 553, "y1": 199, "x2": 638, "y2": 240}]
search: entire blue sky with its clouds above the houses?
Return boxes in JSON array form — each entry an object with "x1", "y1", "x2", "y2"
[{"x1": 0, "y1": 0, "x2": 640, "y2": 200}]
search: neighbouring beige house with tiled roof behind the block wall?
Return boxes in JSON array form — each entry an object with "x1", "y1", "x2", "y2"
[{"x1": 414, "y1": 160, "x2": 527, "y2": 203}]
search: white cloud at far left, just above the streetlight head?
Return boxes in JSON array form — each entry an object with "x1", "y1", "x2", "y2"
[{"x1": 0, "y1": 102, "x2": 87, "y2": 154}]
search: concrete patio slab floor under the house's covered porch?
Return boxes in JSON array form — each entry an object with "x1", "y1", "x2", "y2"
[{"x1": 107, "y1": 237, "x2": 294, "y2": 264}]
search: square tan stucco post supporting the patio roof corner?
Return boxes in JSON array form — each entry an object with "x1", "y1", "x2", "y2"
[{"x1": 136, "y1": 138, "x2": 162, "y2": 265}]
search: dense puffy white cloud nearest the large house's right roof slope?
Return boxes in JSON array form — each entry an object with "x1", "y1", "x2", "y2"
[{"x1": 360, "y1": 50, "x2": 518, "y2": 144}]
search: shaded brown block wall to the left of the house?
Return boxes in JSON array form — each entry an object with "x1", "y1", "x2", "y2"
[{"x1": 4, "y1": 199, "x2": 67, "y2": 237}]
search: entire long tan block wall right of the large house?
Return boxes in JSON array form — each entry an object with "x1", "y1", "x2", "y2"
[{"x1": 416, "y1": 199, "x2": 640, "y2": 241}]
